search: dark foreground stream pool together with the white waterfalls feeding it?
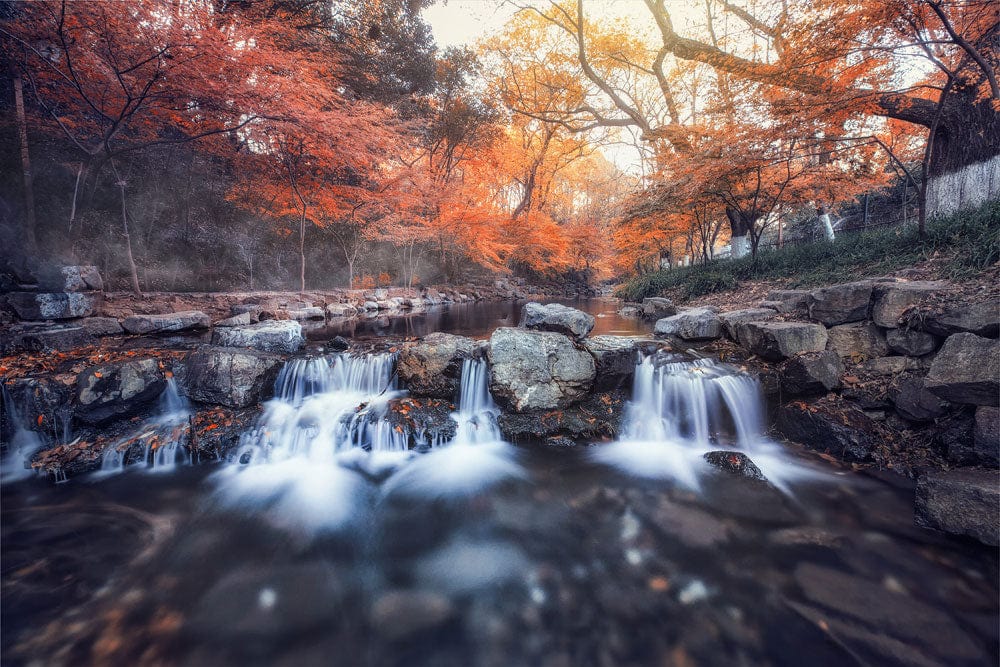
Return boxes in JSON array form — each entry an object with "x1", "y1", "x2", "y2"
[{"x1": 0, "y1": 314, "x2": 1000, "y2": 667}]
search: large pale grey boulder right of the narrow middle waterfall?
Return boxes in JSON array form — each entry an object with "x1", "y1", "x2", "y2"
[{"x1": 489, "y1": 327, "x2": 597, "y2": 412}]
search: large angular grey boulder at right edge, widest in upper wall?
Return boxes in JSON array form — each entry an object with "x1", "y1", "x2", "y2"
[{"x1": 926, "y1": 333, "x2": 1000, "y2": 405}]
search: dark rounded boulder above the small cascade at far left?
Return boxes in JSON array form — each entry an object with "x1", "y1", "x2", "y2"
[{"x1": 74, "y1": 358, "x2": 167, "y2": 424}]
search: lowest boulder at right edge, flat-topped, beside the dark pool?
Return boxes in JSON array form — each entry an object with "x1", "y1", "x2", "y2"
[{"x1": 915, "y1": 470, "x2": 1000, "y2": 547}]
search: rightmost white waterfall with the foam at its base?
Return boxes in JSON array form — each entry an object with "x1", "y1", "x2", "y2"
[{"x1": 593, "y1": 355, "x2": 812, "y2": 489}]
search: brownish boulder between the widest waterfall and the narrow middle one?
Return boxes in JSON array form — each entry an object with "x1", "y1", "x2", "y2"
[{"x1": 396, "y1": 333, "x2": 476, "y2": 400}]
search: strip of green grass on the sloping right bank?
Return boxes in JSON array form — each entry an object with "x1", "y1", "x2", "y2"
[{"x1": 618, "y1": 201, "x2": 1000, "y2": 301}]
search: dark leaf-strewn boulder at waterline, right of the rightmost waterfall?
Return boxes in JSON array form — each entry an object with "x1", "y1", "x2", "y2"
[{"x1": 775, "y1": 401, "x2": 878, "y2": 463}]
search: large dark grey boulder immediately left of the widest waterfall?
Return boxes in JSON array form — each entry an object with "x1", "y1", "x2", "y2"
[{"x1": 183, "y1": 347, "x2": 283, "y2": 408}]
